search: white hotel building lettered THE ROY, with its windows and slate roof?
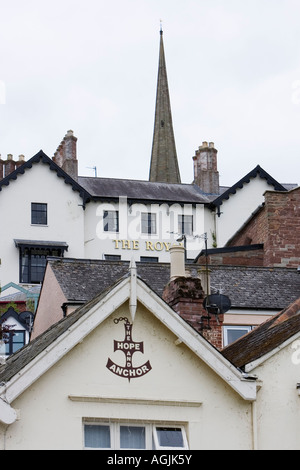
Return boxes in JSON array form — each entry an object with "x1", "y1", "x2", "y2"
[{"x1": 0, "y1": 140, "x2": 290, "y2": 287}]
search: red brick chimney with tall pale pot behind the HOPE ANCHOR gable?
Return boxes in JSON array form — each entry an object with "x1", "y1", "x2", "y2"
[{"x1": 163, "y1": 245, "x2": 223, "y2": 349}]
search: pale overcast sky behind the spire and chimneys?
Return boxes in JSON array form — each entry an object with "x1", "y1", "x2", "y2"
[{"x1": 0, "y1": 0, "x2": 300, "y2": 185}]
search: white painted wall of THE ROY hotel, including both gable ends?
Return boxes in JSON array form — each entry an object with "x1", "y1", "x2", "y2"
[{"x1": 0, "y1": 164, "x2": 278, "y2": 285}]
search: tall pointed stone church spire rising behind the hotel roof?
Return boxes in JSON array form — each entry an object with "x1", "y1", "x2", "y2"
[{"x1": 149, "y1": 28, "x2": 181, "y2": 183}]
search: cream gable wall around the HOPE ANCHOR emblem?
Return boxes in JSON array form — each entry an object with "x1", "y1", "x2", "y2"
[{"x1": 0, "y1": 304, "x2": 252, "y2": 449}]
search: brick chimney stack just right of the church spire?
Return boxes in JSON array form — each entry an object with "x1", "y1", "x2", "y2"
[{"x1": 193, "y1": 142, "x2": 220, "y2": 194}]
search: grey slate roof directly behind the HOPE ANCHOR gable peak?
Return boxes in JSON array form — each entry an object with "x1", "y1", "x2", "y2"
[{"x1": 48, "y1": 258, "x2": 300, "y2": 310}]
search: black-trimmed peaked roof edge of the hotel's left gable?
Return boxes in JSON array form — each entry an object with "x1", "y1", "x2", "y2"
[{"x1": 0, "y1": 150, "x2": 91, "y2": 204}]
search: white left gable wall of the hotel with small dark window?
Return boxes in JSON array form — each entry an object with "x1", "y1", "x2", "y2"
[{"x1": 0, "y1": 164, "x2": 84, "y2": 286}]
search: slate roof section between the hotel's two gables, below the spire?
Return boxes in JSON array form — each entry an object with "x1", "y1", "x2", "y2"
[{"x1": 78, "y1": 176, "x2": 212, "y2": 204}]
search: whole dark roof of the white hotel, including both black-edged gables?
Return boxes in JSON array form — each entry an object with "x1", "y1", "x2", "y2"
[{"x1": 0, "y1": 150, "x2": 297, "y2": 209}]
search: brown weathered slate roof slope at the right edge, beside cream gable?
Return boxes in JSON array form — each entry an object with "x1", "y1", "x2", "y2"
[{"x1": 222, "y1": 298, "x2": 300, "y2": 368}]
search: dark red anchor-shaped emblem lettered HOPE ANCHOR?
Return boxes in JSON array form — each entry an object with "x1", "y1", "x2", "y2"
[{"x1": 106, "y1": 317, "x2": 152, "y2": 382}]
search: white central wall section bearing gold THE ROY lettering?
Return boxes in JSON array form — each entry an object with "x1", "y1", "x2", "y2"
[{"x1": 85, "y1": 198, "x2": 213, "y2": 262}]
